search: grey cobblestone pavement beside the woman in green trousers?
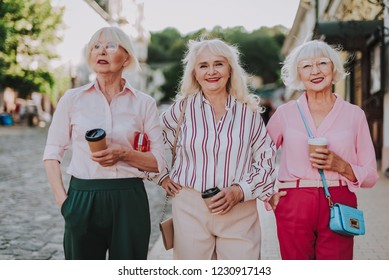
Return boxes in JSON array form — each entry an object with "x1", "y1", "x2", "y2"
[{"x1": 0, "y1": 126, "x2": 170, "y2": 260}]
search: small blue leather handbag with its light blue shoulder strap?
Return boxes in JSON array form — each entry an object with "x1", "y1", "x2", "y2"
[{"x1": 297, "y1": 100, "x2": 365, "y2": 236}]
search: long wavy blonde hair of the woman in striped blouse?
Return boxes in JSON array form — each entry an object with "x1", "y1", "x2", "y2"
[{"x1": 178, "y1": 38, "x2": 261, "y2": 111}]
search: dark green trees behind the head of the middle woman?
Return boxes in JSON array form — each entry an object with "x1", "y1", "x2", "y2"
[{"x1": 148, "y1": 26, "x2": 288, "y2": 101}]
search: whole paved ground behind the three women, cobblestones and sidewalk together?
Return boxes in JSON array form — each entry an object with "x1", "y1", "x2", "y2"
[{"x1": 0, "y1": 126, "x2": 389, "y2": 260}]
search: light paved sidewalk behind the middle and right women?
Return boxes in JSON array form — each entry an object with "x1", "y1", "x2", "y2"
[{"x1": 148, "y1": 174, "x2": 389, "y2": 260}]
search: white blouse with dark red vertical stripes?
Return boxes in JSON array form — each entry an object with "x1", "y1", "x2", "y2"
[{"x1": 160, "y1": 93, "x2": 276, "y2": 201}]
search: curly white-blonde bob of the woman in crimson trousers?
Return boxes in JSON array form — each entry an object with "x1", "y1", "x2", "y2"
[{"x1": 281, "y1": 40, "x2": 347, "y2": 90}]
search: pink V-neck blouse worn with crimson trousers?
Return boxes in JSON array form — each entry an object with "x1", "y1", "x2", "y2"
[{"x1": 267, "y1": 94, "x2": 378, "y2": 191}]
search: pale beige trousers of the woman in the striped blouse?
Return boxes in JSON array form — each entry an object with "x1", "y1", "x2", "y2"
[{"x1": 172, "y1": 187, "x2": 261, "y2": 260}]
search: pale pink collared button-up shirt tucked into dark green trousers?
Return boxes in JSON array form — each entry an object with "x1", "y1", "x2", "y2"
[{"x1": 43, "y1": 81, "x2": 166, "y2": 179}]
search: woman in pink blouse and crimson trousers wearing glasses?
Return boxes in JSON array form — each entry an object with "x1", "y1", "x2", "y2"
[{"x1": 267, "y1": 40, "x2": 378, "y2": 259}]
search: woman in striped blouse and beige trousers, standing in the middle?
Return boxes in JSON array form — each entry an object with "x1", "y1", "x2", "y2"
[{"x1": 157, "y1": 39, "x2": 275, "y2": 259}]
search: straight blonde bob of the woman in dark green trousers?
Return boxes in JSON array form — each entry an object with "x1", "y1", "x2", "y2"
[{"x1": 85, "y1": 26, "x2": 140, "y2": 71}]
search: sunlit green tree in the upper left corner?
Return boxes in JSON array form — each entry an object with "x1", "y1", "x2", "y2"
[{"x1": 0, "y1": 0, "x2": 64, "y2": 98}]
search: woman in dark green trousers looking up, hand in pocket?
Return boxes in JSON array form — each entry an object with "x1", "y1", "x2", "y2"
[{"x1": 43, "y1": 27, "x2": 166, "y2": 259}]
